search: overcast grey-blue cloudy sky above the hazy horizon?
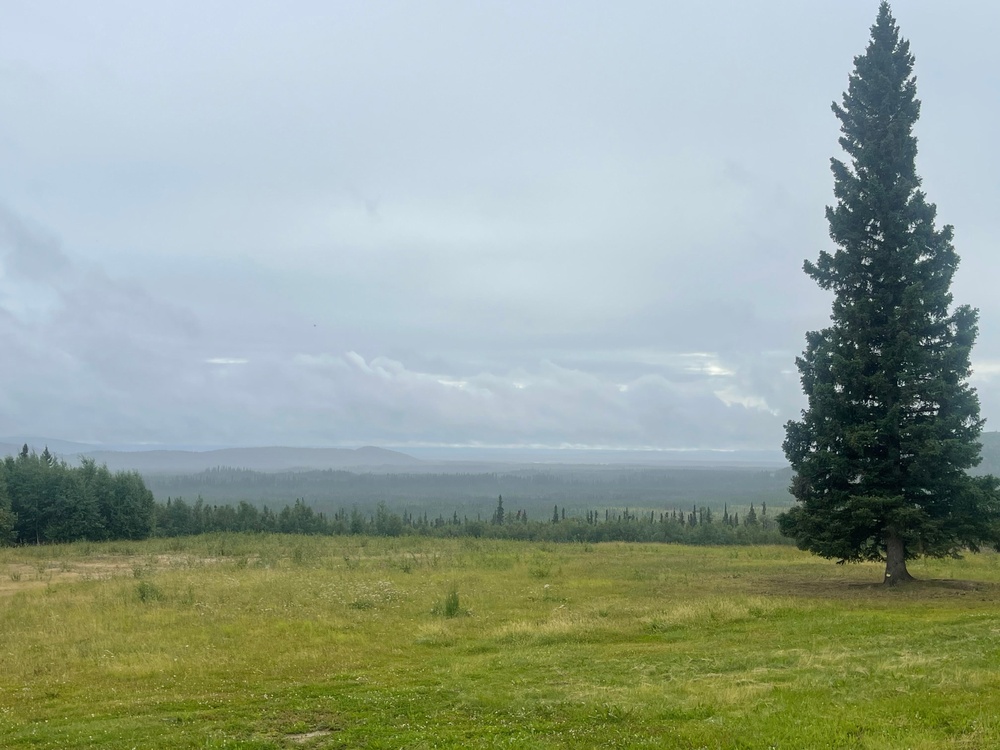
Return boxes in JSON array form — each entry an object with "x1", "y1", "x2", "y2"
[{"x1": 0, "y1": 0, "x2": 1000, "y2": 449}]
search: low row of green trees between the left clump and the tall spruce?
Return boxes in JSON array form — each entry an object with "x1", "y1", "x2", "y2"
[{"x1": 155, "y1": 497, "x2": 790, "y2": 544}]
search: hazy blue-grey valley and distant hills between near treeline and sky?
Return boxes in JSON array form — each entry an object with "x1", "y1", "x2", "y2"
[{"x1": 7, "y1": 432, "x2": 1000, "y2": 519}]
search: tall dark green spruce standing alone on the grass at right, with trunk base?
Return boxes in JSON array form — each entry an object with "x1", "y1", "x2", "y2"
[{"x1": 780, "y1": 2, "x2": 1000, "y2": 584}]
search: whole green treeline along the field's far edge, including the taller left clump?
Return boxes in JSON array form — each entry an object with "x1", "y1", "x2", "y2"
[{"x1": 0, "y1": 446, "x2": 785, "y2": 544}]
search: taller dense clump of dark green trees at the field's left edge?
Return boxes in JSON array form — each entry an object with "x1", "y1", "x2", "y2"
[{"x1": 0, "y1": 445, "x2": 155, "y2": 544}]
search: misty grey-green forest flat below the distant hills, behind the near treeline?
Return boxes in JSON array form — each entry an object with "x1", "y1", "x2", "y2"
[{"x1": 146, "y1": 465, "x2": 791, "y2": 518}]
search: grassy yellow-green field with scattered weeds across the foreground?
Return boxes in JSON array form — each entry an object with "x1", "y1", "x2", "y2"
[{"x1": 0, "y1": 535, "x2": 1000, "y2": 748}]
